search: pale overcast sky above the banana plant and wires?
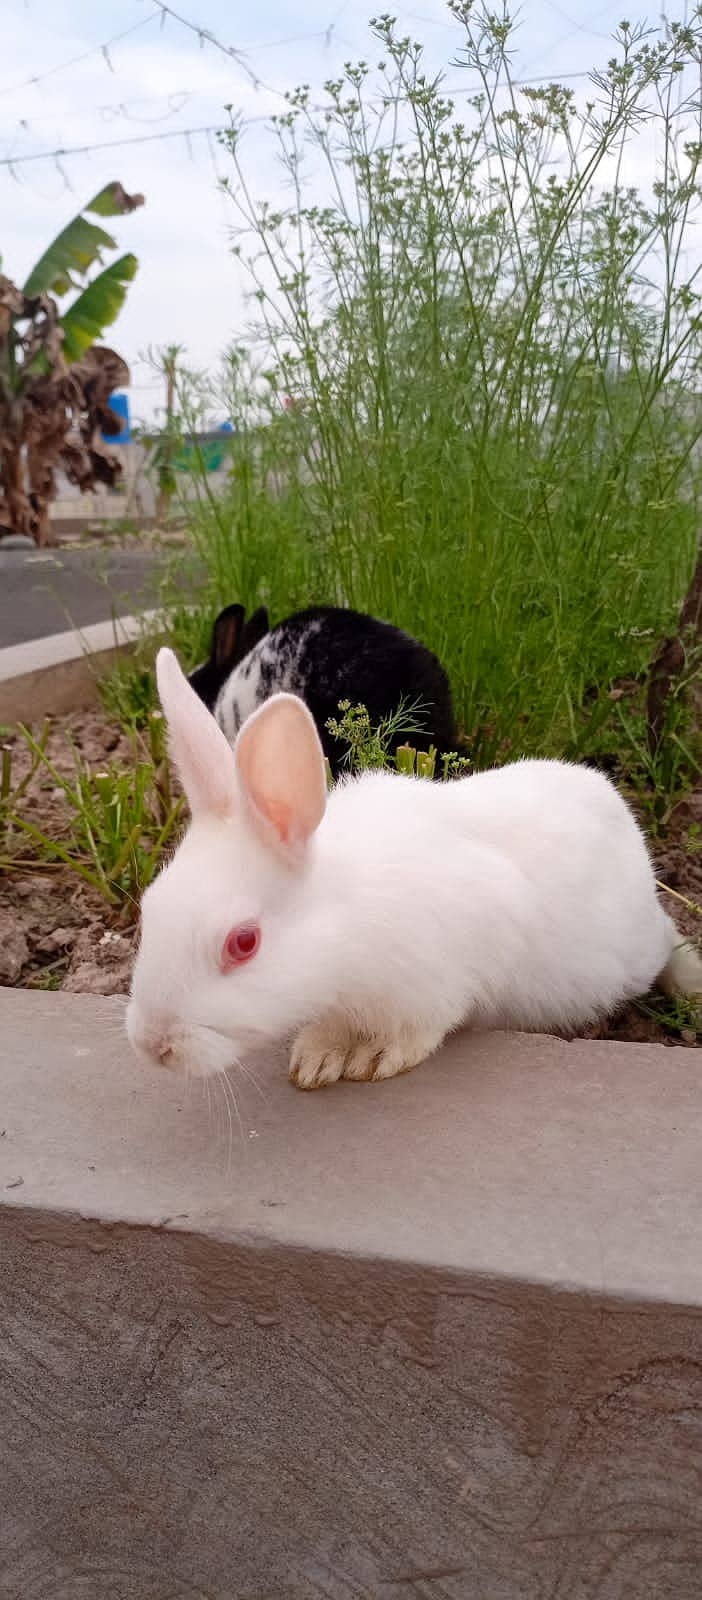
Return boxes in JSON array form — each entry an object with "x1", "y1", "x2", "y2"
[{"x1": 0, "y1": 0, "x2": 676, "y2": 416}]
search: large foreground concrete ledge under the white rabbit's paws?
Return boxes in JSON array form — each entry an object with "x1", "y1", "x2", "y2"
[{"x1": 0, "y1": 990, "x2": 702, "y2": 1600}]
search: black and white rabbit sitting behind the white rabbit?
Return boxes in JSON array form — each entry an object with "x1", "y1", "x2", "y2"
[{"x1": 190, "y1": 605, "x2": 457, "y2": 776}]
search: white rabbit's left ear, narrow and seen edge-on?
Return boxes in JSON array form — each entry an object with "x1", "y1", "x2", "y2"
[{"x1": 157, "y1": 650, "x2": 238, "y2": 816}]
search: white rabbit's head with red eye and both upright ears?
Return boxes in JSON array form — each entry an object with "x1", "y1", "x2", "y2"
[{"x1": 126, "y1": 650, "x2": 328, "y2": 1077}]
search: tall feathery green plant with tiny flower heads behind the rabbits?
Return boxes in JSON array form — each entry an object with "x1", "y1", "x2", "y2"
[{"x1": 170, "y1": 5, "x2": 702, "y2": 760}]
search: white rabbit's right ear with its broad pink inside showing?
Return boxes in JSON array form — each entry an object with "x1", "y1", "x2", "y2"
[{"x1": 233, "y1": 694, "x2": 326, "y2": 854}]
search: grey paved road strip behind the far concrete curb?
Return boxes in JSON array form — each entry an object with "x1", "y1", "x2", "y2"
[{"x1": 0, "y1": 547, "x2": 199, "y2": 650}]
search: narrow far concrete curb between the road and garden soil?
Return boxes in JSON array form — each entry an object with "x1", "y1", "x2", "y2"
[{"x1": 0, "y1": 611, "x2": 160, "y2": 722}]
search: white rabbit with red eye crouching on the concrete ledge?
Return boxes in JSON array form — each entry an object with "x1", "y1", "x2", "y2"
[{"x1": 126, "y1": 650, "x2": 702, "y2": 1088}]
